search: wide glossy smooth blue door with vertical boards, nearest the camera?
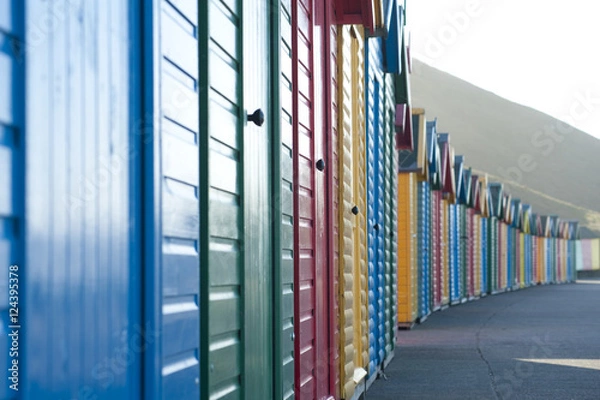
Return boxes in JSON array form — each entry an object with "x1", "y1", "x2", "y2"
[{"x1": 24, "y1": 0, "x2": 141, "y2": 399}]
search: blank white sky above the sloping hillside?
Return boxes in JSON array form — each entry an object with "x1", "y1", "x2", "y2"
[{"x1": 407, "y1": 0, "x2": 600, "y2": 138}]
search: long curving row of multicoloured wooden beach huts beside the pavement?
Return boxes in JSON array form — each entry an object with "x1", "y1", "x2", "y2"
[{"x1": 0, "y1": 0, "x2": 588, "y2": 400}]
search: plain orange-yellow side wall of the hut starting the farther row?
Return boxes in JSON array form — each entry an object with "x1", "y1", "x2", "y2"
[{"x1": 398, "y1": 173, "x2": 418, "y2": 323}]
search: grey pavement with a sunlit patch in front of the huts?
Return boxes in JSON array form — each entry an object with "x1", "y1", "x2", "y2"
[{"x1": 366, "y1": 279, "x2": 600, "y2": 400}]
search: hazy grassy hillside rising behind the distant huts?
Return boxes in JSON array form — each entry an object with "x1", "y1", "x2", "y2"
[{"x1": 411, "y1": 60, "x2": 600, "y2": 237}]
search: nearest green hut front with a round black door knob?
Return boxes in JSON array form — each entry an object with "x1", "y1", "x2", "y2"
[{"x1": 199, "y1": 0, "x2": 293, "y2": 399}]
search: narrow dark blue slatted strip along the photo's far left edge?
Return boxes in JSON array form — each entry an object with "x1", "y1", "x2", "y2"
[{"x1": 0, "y1": 0, "x2": 22, "y2": 399}]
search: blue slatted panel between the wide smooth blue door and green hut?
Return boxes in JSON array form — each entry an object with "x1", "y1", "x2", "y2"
[{"x1": 142, "y1": 0, "x2": 201, "y2": 399}]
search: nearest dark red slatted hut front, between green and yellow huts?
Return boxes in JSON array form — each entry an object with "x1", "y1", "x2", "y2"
[{"x1": 291, "y1": 0, "x2": 337, "y2": 399}]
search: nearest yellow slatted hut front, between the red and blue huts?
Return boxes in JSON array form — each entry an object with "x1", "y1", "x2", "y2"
[{"x1": 337, "y1": 26, "x2": 368, "y2": 398}]
